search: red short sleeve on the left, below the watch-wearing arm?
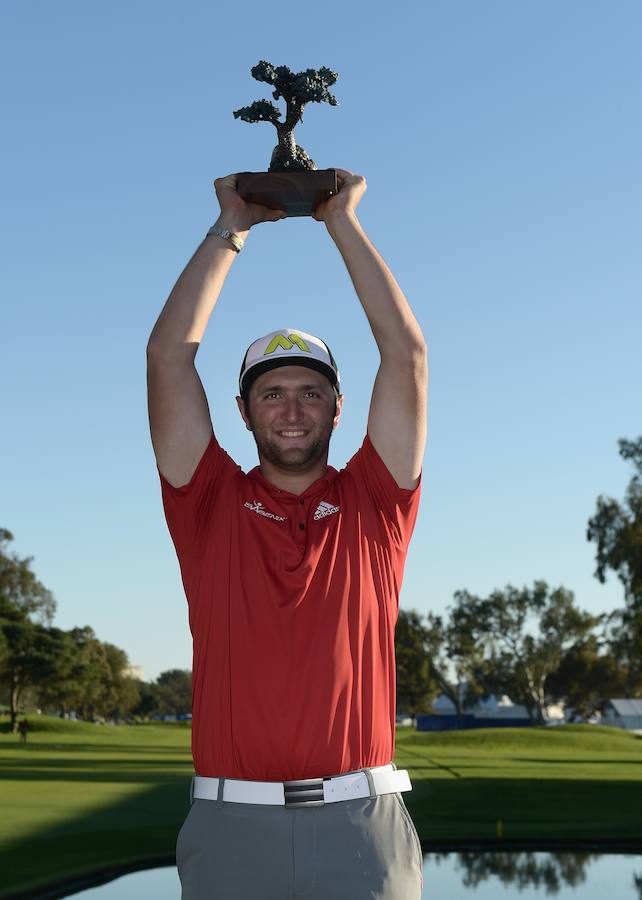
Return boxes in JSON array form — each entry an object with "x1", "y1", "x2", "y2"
[{"x1": 156, "y1": 434, "x2": 241, "y2": 556}]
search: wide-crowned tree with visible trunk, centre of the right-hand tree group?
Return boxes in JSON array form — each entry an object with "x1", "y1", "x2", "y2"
[{"x1": 455, "y1": 581, "x2": 599, "y2": 724}]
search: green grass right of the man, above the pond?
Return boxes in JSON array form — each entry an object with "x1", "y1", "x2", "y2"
[{"x1": 395, "y1": 725, "x2": 642, "y2": 844}]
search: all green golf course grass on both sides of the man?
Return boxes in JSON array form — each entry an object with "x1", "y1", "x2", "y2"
[{"x1": 0, "y1": 716, "x2": 642, "y2": 896}]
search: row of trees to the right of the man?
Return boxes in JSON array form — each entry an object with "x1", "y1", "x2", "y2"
[{"x1": 395, "y1": 438, "x2": 642, "y2": 724}]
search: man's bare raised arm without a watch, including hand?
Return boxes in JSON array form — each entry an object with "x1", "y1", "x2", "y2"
[{"x1": 314, "y1": 169, "x2": 428, "y2": 489}]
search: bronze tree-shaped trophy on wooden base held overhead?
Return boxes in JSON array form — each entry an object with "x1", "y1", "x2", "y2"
[{"x1": 234, "y1": 60, "x2": 338, "y2": 216}]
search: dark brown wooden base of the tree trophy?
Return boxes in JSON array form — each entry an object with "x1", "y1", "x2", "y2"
[{"x1": 236, "y1": 169, "x2": 338, "y2": 216}]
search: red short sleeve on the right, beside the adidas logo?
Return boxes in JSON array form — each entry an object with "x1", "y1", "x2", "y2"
[{"x1": 346, "y1": 433, "x2": 422, "y2": 550}]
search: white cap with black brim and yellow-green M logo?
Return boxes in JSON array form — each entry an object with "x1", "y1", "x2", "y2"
[{"x1": 239, "y1": 328, "x2": 340, "y2": 394}]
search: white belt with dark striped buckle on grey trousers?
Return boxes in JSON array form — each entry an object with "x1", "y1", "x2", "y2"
[{"x1": 190, "y1": 763, "x2": 412, "y2": 808}]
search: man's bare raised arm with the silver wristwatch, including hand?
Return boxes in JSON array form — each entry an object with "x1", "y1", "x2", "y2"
[{"x1": 147, "y1": 175, "x2": 285, "y2": 487}]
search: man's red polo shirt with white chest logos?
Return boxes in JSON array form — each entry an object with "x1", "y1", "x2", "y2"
[{"x1": 159, "y1": 435, "x2": 421, "y2": 781}]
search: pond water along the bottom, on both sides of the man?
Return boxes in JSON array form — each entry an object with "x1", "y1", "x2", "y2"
[{"x1": 67, "y1": 851, "x2": 642, "y2": 900}]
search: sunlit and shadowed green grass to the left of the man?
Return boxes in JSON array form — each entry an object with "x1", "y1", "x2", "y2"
[{"x1": 0, "y1": 716, "x2": 193, "y2": 896}]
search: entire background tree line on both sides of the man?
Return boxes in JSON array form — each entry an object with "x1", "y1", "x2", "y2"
[{"x1": 0, "y1": 437, "x2": 642, "y2": 731}]
